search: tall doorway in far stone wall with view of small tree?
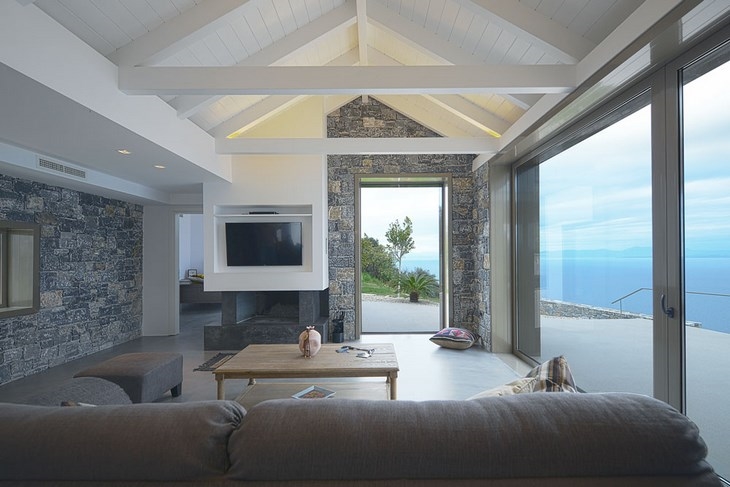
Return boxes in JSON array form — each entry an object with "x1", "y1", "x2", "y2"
[{"x1": 356, "y1": 176, "x2": 449, "y2": 333}]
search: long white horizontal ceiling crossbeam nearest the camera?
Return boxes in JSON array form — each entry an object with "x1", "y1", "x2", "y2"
[{"x1": 119, "y1": 65, "x2": 576, "y2": 95}]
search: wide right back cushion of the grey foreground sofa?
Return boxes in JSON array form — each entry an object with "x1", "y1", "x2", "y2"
[{"x1": 229, "y1": 393, "x2": 711, "y2": 481}]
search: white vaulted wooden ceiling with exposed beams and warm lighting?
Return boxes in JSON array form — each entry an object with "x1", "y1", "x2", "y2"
[{"x1": 0, "y1": 0, "x2": 730, "y2": 202}]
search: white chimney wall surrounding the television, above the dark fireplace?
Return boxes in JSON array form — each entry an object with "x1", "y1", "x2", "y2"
[{"x1": 203, "y1": 155, "x2": 329, "y2": 291}]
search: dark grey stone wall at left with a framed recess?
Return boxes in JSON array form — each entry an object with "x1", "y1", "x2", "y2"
[{"x1": 0, "y1": 175, "x2": 142, "y2": 384}]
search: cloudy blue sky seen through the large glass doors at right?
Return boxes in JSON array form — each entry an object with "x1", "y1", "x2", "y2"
[{"x1": 540, "y1": 59, "x2": 730, "y2": 252}]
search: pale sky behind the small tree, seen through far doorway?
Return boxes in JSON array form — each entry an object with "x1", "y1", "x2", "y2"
[{"x1": 360, "y1": 187, "x2": 441, "y2": 261}]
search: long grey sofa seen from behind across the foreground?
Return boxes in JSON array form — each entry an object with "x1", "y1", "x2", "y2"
[{"x1": 0, "y1": 393, "x2": 720, "y2": 487}]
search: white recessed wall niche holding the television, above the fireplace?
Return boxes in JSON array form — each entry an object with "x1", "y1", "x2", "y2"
[{"x1": 214, "y1": 205, "x2": 312, "y2": 273}]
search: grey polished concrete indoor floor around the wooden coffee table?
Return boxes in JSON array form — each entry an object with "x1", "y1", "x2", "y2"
[{"x1": 0, "y1": 305, "x2": 527, "y2": 402}]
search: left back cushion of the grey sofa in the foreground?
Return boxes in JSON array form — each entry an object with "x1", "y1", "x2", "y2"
[{"x1": 0, "y1": 401, "x2": 245, "y2": 482}]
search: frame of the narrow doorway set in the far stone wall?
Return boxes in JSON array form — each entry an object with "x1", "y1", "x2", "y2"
[{"x1": 355, "y1": 174, "x2": 452, "y2": 338}]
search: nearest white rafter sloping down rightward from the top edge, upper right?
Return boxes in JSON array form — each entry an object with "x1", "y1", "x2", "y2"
[{"x1": 465, "y1": 0, "x2": 596, "y2": 64}]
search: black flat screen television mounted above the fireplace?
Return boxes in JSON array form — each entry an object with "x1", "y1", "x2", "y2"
[{"x1": 226, "y1": 222, "x2": 302, "y2": 267}]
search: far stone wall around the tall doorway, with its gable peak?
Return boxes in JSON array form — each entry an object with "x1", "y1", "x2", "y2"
[{"x1": 327, "y1": 98, "x2": 480, "y2": 340}]
